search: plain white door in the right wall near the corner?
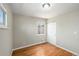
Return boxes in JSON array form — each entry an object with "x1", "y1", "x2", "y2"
[{"x1": 47, "y1": 22, "x2": 56, "y2": 44}]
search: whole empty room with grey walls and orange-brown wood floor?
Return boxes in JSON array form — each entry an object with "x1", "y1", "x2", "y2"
[{"x1": 0, "y1": 3, "x2": 79, "y2": 56}]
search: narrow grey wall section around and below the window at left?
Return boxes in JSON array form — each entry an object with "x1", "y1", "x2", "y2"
[{"x1": 0, "y1": 4, "x2": 12, "y2": 56}]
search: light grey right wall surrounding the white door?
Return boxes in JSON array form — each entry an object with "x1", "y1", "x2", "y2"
[{"x1": 48, "y1": 11, "x2": 79, "y2": 55}]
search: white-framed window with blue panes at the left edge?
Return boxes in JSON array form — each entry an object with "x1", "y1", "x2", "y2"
[{"x1": 0, "y1": 5, "x2": 7, "y2": 28}]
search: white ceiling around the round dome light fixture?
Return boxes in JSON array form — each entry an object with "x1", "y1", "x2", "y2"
[{"x1": 9, "y1": 3, "x2": 79, "y2": 18}]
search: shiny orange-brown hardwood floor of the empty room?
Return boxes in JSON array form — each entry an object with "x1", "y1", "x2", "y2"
[{"x1": 13, "y1": 43, "x2": 73, "y2": 56}]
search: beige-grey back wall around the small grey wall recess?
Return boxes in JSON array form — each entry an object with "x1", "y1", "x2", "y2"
[{"x1": 13, "y1": 15, "x2": 46, "y2": 49}]
